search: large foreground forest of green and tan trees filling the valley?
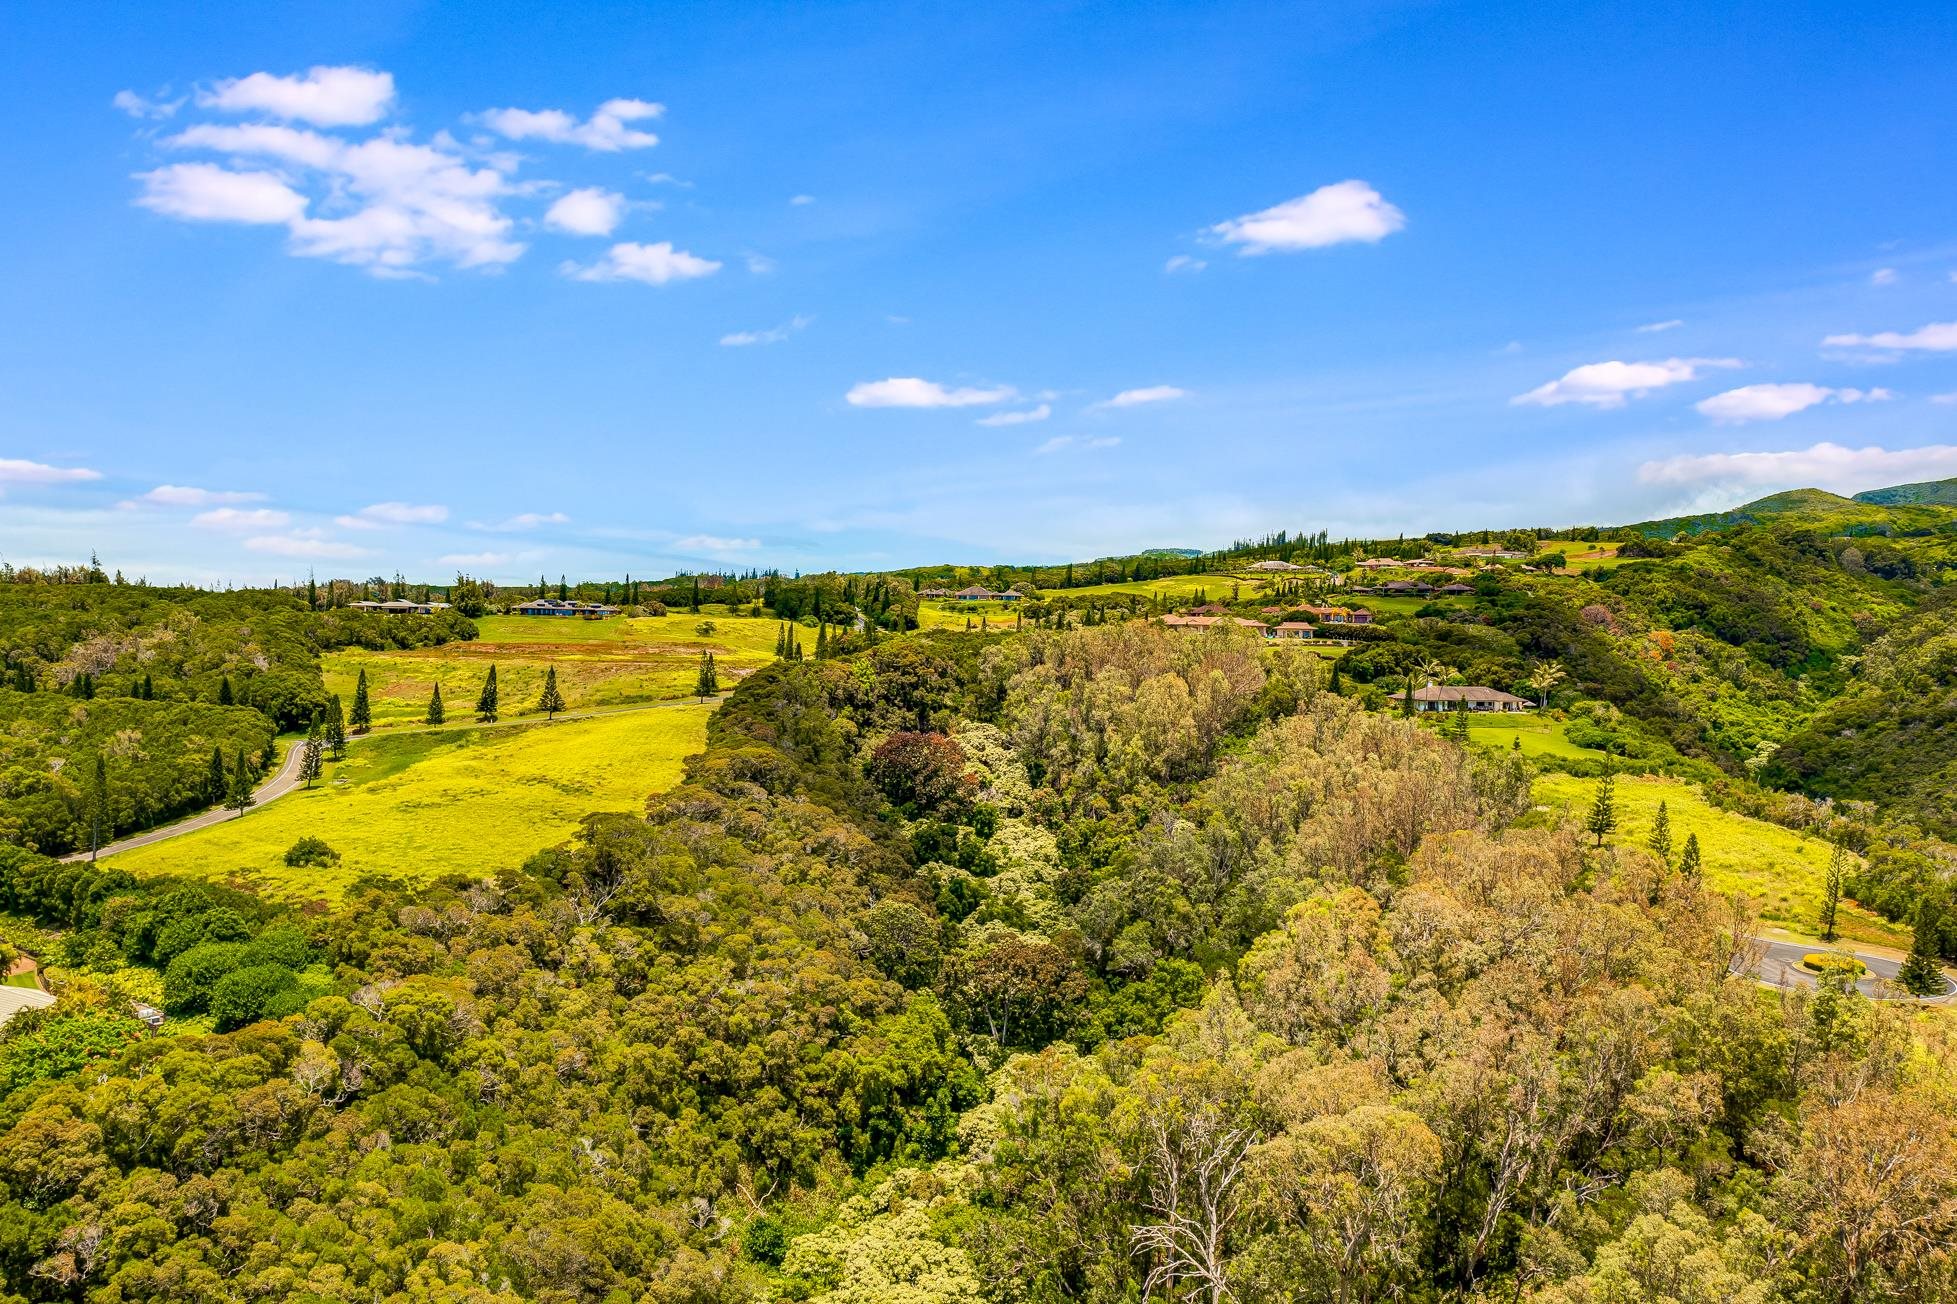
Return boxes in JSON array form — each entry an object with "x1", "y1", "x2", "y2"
[{"x1": 0, "y1": 627, "x2": 1957, "y2": 1304}]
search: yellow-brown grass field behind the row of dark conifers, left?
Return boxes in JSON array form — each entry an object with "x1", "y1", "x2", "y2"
[{"x1": 321, "y1": 609, "x2": 774, "y2": 728}]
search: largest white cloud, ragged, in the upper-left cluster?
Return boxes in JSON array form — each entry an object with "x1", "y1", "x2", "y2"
[{"x1": 153, "y1": 123, "x2": 524, "y2": 276}]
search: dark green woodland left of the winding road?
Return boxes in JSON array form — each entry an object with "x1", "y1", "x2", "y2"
[{"x1": 0, "y1": 583, "x2": 476, "y2": 854}]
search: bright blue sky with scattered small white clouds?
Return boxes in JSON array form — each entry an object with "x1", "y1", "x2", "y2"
[{"x1": 0, "y1": 2, "x2": 1957, "y2": 580}]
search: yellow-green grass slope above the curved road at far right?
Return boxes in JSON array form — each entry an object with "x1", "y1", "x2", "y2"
[{"x1": 1525, "y1": 771, "x2": 1910, "y2": 948}]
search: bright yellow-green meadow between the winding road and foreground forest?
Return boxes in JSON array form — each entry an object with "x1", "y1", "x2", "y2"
[{"x1": 114, "y1": 703, "x2": 712, "y2": 903}]
